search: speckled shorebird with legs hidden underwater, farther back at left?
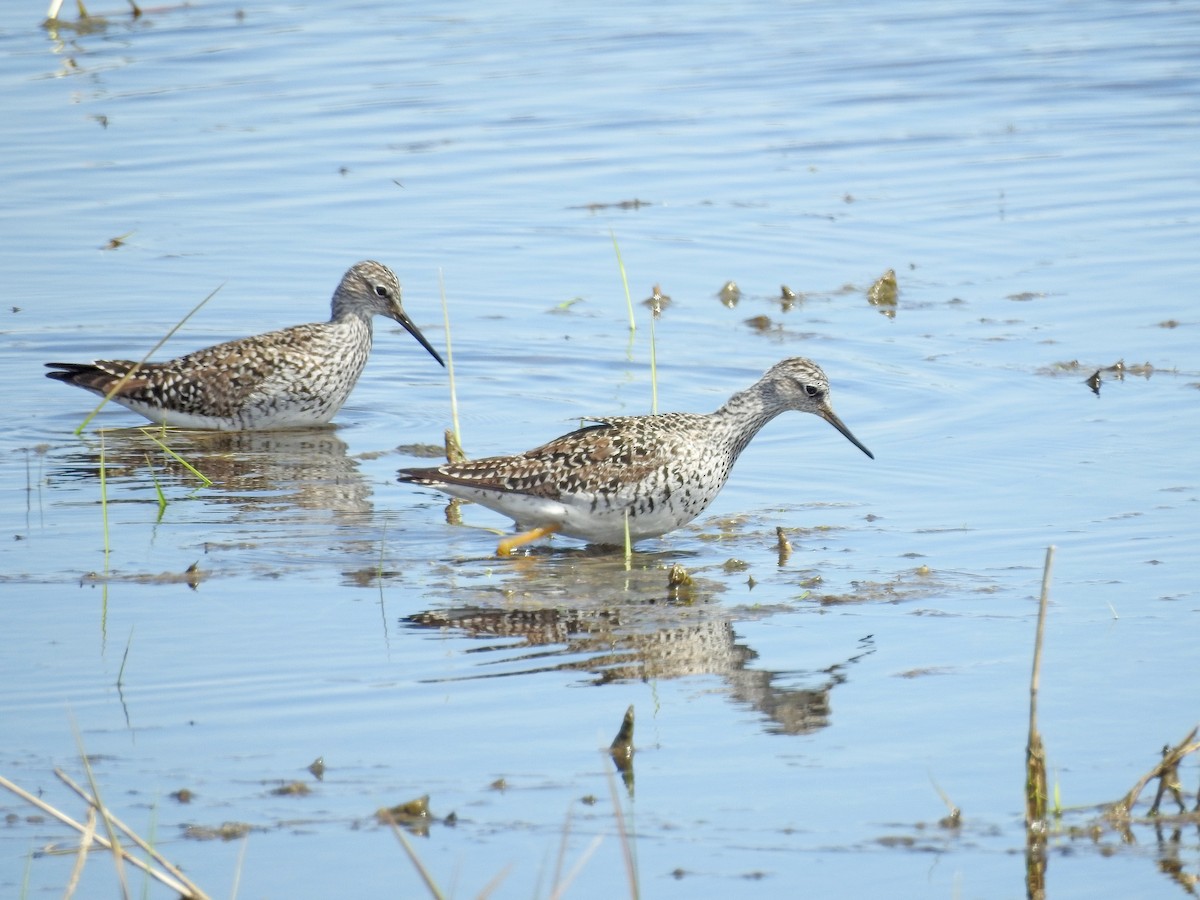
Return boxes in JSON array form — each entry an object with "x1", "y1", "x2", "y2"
[{"x1": 46, "y1": 260, "x2": 445, "y2": 431}]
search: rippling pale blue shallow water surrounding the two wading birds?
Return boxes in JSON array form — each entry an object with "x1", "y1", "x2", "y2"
[{"x1": 0, "y1": 2, "x2": 1200, "y2": 898}]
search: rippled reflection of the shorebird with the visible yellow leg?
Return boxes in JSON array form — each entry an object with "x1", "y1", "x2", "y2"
[{"x1": 401, "y1": 552, "x2": 874, "y2": 734}]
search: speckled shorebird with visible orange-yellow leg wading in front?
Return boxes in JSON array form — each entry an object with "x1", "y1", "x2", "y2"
[{"x1": 400, "y1": 358, "x2": 875, "y2": 556}]
